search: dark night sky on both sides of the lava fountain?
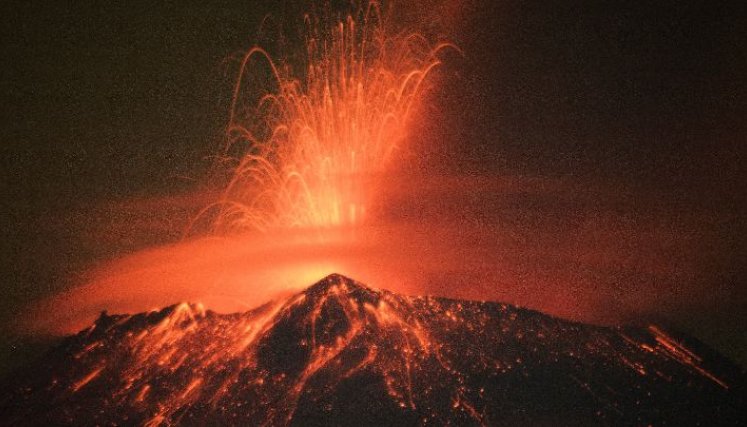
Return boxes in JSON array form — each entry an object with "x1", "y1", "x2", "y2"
[{"x1": 0, "y1": 0, "x2": 747, "y2": 374}]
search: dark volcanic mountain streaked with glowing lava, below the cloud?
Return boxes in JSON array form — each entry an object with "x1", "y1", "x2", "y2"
[{"x1": 0, "y1": 275, "x2": 744, "y2": 426}]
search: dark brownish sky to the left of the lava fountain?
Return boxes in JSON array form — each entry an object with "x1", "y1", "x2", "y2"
[{"x1": 0, "y1": 2, "x2": 261, "y2": 304}]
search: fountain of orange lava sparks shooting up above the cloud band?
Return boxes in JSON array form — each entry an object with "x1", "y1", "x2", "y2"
[{"x1": 197, "y1": 2, "x2": 447, "y2": 231}]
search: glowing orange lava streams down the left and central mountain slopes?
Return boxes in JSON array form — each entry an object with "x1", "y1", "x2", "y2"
[{"x1": 60, "y1": 276, "x2": 490, "y2": 425}]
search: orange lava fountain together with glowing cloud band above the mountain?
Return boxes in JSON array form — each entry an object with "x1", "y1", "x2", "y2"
[{"x1": 20, "y1": 3, "x2": 722, "y2": 348}]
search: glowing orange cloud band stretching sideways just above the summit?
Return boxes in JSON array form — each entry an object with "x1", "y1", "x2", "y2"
[{"x1": 23, "y1": 171, "x2": 720, "y2": 334}]
